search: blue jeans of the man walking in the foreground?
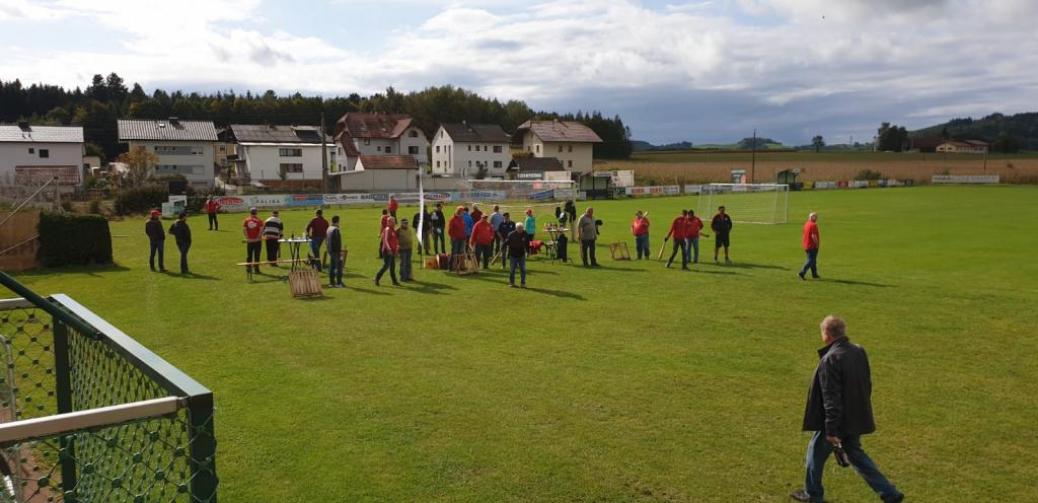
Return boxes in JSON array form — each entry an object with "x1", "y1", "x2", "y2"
[{"x1": 803, "y1": 431, "x2": 901, "y2": 502}]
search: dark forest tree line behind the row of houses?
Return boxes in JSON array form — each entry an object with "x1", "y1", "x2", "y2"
[{"x1": 0, "y1": 73, "x2": 631, "y2": 160}]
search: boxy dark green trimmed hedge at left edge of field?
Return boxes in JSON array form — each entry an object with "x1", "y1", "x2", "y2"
[{"x1": 37, "y1": 213, "x2": 112, "y2": 268}]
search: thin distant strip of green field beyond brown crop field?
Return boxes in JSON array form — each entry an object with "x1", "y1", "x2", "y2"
[{"x1": 631, "y1": 150, "x2": 1038, "y2": 163}]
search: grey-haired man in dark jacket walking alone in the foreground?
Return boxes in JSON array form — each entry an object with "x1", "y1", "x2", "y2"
[{"x1": 790, "y1": 315, "x2": 904, "y2": 503}]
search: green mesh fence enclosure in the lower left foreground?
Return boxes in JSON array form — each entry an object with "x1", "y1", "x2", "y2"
[{"x1": 0, "y1": 278, "x2": 217, "y2": 503}]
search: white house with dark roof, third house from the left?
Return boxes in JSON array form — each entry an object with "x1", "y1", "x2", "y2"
[{"x1": 225, "y1": 124, "x2": 337, "y2": 188}]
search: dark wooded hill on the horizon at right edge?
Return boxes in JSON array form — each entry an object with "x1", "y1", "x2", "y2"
[{"x1": 908, "y1": 112, "x2": 1038, "y2": 151}]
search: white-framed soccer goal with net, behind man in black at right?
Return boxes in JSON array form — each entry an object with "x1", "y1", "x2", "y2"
[{"x1": 699, "y1": 184, "x2": 789, "y2": 224}]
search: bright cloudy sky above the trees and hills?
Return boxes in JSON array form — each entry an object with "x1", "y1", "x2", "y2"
[{"x1": 0, "y1": 0, "x2": 1038, "y2": 144}]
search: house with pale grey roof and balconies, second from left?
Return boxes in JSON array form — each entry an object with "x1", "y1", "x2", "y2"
[{"x1": 118, "y1": 117, "x2": 217, "y2": 187}]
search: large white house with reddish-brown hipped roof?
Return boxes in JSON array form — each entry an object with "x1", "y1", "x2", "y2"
[{"x1": 335, "y1": 113, "x2": 429, "y2": 171}]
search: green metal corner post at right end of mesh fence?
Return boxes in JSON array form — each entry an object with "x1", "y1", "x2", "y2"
[{"x1": 188, "y1": 393, "x2": 218, "y2": 503}]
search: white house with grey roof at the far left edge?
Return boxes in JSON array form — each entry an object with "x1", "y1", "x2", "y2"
[{"x1": 0, "y1": 122, "x2": 84, "y2": 187}]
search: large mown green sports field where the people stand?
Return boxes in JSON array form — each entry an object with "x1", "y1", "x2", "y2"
[{"x1": 10, "y1": 187, "x2": 1038, "y2": 503}]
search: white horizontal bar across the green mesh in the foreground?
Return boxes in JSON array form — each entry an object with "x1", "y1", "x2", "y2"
[{"x1": 0, "y1": 396, "x2": 182, "y2": 445}]
